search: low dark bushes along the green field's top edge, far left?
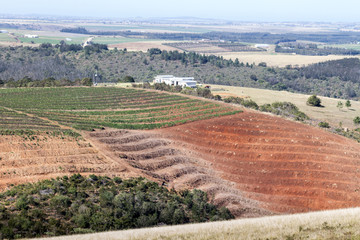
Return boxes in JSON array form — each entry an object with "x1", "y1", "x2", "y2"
[{"x1": 0, "y1": 76, "x2": 93, "y2": 88}]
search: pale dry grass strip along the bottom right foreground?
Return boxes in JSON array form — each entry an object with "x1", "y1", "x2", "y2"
[{"x1": 34, "y1": 208, "x2": 360, "y2": 240}]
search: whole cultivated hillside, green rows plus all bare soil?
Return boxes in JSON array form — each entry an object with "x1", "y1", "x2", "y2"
[{"x1": 0, "y1": 88, "x2": 360, "y2": 217}]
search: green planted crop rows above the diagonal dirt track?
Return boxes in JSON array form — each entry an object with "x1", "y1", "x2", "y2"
[{"x1": 0, "y1": 87, "x2": 239, "y2": 130}]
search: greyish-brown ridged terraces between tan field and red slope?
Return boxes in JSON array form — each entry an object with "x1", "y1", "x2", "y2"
[{"x1": 86, "y1": 130, "x2": 271, "y2": 217}]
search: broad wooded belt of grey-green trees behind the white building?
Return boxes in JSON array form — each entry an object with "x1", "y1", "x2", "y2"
[{"x1": 0, "y1": 45, "x2": 360, "y2": 99}]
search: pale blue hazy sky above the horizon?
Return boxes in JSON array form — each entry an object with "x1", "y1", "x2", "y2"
[{"x1": 0, "y1": 0, "x2": 360, "y2": 22}]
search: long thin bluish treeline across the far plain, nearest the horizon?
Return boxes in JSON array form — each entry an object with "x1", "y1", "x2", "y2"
[{"x1": 61, "y1": 27, "x2": 360, "y2": 44}]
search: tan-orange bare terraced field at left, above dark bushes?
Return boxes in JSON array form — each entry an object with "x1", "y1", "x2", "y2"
[{"x1": 0, "y1": 134, "x2": 132, "y2": 190}]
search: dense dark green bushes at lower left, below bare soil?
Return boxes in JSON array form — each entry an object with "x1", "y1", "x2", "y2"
[{"x1": 0, "y1": 174, "x2": 234, "y2": 239}]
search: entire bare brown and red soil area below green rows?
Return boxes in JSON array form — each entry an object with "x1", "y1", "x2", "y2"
[{"x1": 0, "y1": 111, "x2": 360, "y2": 217}]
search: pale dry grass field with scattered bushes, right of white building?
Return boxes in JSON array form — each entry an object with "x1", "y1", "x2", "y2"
[{"x1": 211, "y1": 85, "x2": 360, "y2": 129}]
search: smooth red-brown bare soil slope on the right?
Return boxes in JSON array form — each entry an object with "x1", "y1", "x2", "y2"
[{"x1": 156, "y1": 111, "x2": 360, "y2": 213}]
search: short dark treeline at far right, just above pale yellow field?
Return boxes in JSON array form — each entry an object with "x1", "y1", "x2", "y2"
[{"x1": 275, "y1": 44, "x2": 360, "y2": 56}]
